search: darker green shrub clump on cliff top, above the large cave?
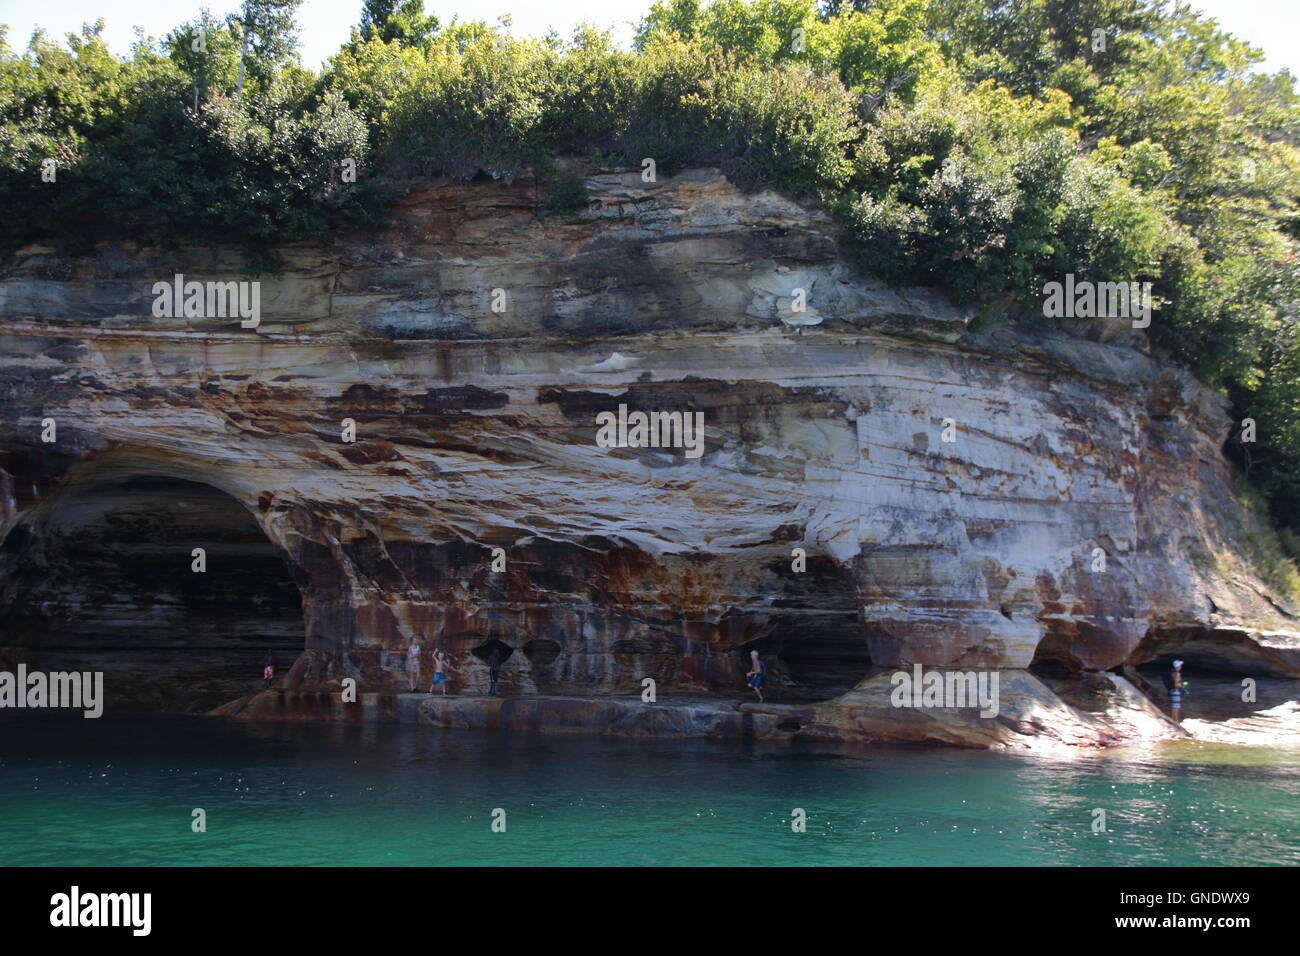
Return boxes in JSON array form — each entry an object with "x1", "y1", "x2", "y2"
[{"x1": 0, "y1": 25, "x2": 368, "y2": 261}]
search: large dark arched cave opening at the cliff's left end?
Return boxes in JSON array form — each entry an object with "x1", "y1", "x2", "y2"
[{"x1": 0, "y1": 475, "x2": 303, "y2": 711}]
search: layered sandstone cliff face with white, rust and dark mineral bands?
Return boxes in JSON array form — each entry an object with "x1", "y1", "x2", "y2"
[{"x1": 0, "y1": 170, "x2": 1300, "y2": 743}]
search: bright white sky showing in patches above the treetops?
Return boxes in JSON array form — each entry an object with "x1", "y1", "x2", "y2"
[{"x1": 0, "y1": 0, "x2": 1300, "y2": 77}]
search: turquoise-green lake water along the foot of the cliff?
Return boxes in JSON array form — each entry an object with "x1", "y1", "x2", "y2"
[{"x1": 0, "y1": 714, "x2": 1300, "y2": 866}]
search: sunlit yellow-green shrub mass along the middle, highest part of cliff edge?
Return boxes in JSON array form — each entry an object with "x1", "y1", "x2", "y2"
[{"x1": 377, "y1": 30, "x2": 861, "y2": 196}]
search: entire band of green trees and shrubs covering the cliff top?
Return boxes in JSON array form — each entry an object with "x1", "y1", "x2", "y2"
[{"x1": 0, "y1": 0, "x2": 1300, "y2": 538}]
